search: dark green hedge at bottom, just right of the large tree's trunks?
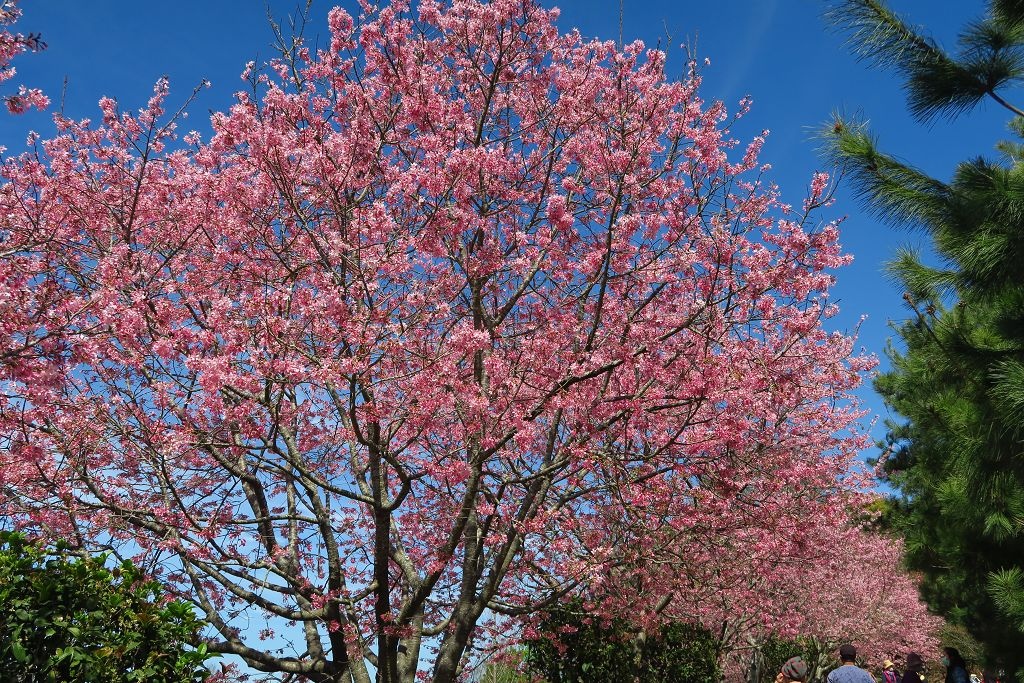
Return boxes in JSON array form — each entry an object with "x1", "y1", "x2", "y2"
[{"x1": 526, "y1": 603, "x2": 721, "y2": 683}]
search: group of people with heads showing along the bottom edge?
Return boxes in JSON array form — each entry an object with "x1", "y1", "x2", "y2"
[{"x1": 775, "y1": 643, "x2": 1001, "y2": 683}]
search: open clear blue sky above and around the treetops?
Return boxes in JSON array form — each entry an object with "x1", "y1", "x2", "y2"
[{"x1": 6, "y1": 0, "x2": 1009, "y2": 458}]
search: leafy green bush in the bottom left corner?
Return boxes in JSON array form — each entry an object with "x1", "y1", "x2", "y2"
[{"x1": 0, "y1": 531, "x2": 211, "y2": 683}]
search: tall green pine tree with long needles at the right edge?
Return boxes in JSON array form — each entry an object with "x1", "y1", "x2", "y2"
[{"x1": 826, "y1": 0, "x2": 1024, "y2": 677}]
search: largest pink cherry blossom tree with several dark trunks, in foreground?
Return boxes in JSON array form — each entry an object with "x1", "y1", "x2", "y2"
[{"x1": 0, "y1": 0, "x2": 872, "y2": 683}]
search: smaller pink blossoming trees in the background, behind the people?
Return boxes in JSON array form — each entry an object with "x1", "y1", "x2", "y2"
[{"x1": 573, "y1": 473, "x2": 943, "y2": 680}]
